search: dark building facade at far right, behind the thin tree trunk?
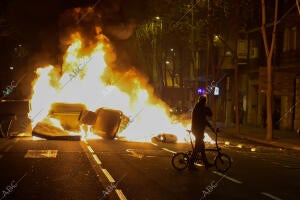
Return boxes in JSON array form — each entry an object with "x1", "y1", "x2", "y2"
[{"x1": 239, "y1": 1, "x2": 300, "y2": 130}]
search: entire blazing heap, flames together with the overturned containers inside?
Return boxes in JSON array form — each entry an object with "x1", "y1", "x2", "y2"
[{"x1": 29, "y1": 27, "x2": 190, "y2": 141}]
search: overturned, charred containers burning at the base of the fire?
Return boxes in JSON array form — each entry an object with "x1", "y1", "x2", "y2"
[{"x1": 32, "y1": 103, "x2": 129, "y2": 140}]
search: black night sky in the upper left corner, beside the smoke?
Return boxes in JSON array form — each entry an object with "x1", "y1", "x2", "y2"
[{"x1": 0, "y1": 0, "x2": 89, "y2": 70}]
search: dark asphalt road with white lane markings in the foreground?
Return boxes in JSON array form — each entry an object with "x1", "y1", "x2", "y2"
[{"x1": 0, "y1": 135, "x2": 300, "y2": 200}]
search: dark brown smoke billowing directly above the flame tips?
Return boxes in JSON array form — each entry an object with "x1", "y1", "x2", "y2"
[{"x1": 59, "y1": 0, "x2": 138, "y2": 70}]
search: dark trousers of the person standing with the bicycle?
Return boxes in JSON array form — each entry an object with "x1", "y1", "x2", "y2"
[{"x1": 190, "y1": 131, "x2": 208, "y2": 165}]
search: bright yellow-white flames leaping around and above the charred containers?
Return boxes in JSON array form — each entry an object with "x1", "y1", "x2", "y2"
[{"x1": 29, "y1": 29, "x2": 211, "y2": 142}]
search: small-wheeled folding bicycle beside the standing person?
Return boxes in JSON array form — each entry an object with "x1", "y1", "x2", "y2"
[{"x1": 172, "y1": 129, "x2": 231, "y2": 173}]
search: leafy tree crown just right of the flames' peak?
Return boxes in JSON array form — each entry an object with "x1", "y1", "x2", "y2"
[{"x1": 135, "y1": 0, "x2": 191, "y2": 89}]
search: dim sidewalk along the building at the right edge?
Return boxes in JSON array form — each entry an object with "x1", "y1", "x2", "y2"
[{"x1": 222, "y1": 126, "x2": 300, "y2": 151}]
